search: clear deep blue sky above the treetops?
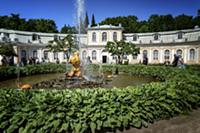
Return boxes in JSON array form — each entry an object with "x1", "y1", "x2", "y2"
[{"x1": 0, "y1": 0, "x2": 200, "y2": 29}]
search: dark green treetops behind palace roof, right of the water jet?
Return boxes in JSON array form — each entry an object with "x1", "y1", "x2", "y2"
[{"x1": 100, "y1": 10, "x2": 200, "y2": 33}]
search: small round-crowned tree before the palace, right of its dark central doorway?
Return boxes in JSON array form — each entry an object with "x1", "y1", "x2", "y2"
[{"x1": 105, "y1": 41, "x2": 140, "y2": 64}]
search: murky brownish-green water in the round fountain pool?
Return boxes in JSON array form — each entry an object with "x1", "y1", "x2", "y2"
[{"x1": 0, "y1": 73, "x2": 158, "y2": 88}]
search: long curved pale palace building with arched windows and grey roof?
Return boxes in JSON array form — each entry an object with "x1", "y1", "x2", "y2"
[{"x1": 0, "y1": 25, "x2": 200, "y2": 64}]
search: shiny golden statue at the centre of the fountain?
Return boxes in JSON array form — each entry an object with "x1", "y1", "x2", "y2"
[{"x1": 66, "y1": 52, "x2": 81, "y2": 79}]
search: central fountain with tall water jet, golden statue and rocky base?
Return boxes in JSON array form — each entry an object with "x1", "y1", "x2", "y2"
[{"x1": 33, "y1": 0, "x2": 103, "y2": 89}]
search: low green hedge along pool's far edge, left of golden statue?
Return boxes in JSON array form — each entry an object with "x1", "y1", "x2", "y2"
[{"x1": 0, "y1": 64, "x2": 66, "y2": 81}]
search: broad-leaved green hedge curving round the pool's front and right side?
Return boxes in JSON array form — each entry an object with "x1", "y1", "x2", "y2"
[{"x1": 0, "y1": 65, "x2": 200, "y2": 133}]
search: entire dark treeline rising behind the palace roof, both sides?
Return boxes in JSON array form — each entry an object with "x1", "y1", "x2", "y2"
[{"x1": 0, "y1": 9, "x2": 200, "y2": 34}]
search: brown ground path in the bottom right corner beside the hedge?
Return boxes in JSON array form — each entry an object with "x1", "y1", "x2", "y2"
[{"x1": 117, "y1": 109, "x2": 200, "y2": 133}]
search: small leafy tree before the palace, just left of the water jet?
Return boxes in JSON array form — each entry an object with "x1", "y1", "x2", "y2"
[{"x1": 46, "y1": 34, "x2": 77, "y2": 60}]
